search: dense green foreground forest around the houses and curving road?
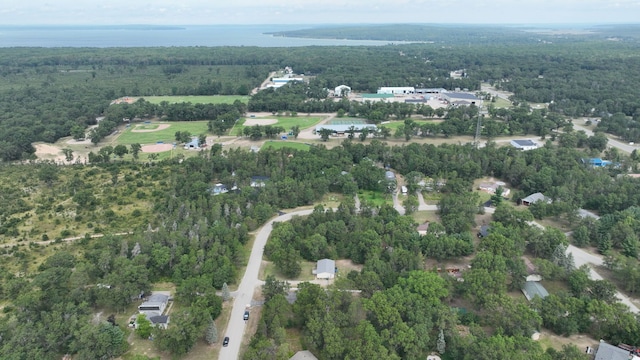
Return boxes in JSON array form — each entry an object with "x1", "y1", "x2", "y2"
[{"x1": 0, "y1": 131, "x2": 640, "y2": 359}]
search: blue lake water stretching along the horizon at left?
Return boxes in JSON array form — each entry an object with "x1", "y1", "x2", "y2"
[{"x1": 0, "y1": 25, "x2": 402, "y2": 48}]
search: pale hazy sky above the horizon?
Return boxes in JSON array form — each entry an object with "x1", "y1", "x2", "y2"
[{"x1": 0, "y1": 0, "x2": 640, "y2": 25}]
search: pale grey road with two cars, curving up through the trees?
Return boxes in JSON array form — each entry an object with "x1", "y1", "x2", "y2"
[{"x1": 219, "y1": 209, "x2": 313, "y2": 360}]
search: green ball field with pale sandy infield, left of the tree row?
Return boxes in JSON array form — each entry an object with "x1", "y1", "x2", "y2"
[{"x1": 115, "y1": 121, "x2": 208, "y2": 145}]
